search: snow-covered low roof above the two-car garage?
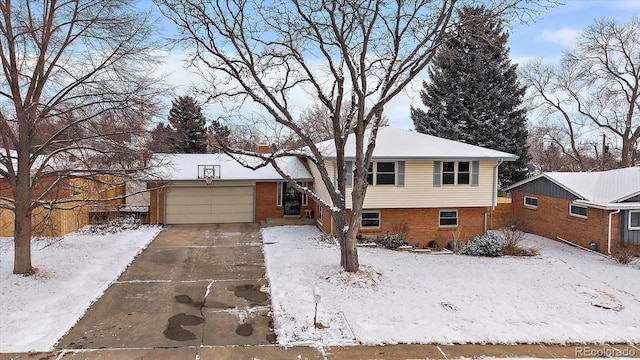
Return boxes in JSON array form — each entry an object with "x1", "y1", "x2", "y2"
[{"x1": 150, "y1": 154, "x2": 313, "y2": 181}]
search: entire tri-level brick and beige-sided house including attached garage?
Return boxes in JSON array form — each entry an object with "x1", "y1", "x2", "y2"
[{"x1": 148, "y1": 127, "x2": 517, "y2": 246}]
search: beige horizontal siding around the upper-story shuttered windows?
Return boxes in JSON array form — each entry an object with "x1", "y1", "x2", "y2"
[{"x1": 347, "y1": 161, "x2": 496, "y2": 209}]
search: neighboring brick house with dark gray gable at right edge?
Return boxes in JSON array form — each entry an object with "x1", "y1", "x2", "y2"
[{"x1": 507, "y1": 167, "x2": 640, "y2": 254}]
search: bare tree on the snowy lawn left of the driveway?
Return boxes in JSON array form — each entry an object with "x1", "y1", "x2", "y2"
[{"x1": 0, "y1": 0, "x2": 165, "y2": 274}]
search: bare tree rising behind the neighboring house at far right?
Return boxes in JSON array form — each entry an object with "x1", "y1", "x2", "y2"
[{"x1": 521, "y1": 18, "x2": 640, "y2": 170}]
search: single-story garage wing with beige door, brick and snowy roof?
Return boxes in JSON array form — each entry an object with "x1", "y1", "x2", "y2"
[{"x1": 147, "y1": 154, "x2": 313, "y2": 224}]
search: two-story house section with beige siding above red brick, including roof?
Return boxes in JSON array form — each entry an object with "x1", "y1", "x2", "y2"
[{"x1": 310, "y1": 127, "x2": 517, "y2": 247}]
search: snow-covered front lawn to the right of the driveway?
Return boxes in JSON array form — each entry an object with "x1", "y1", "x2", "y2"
[{"x1": 262, "y1": 226, "x2": 640, "y2": 345}]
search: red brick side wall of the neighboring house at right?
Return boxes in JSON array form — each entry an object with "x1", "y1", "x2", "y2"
[{"x1": 512, "y1": 191, "x2": 622, "y2": 253}]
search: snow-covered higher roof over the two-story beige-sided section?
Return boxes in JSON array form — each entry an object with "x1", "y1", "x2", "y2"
[{"x1": 317, "y1": 126, "x2": 518, "y2": 161}]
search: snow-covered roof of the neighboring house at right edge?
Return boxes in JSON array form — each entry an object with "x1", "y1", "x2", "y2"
[{"x1": 507, "y1": 167, "x2": 640, "y2": 208}]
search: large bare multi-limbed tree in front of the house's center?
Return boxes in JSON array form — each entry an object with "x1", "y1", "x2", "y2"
[{"x1": 155, "y1": 0, "x2": 556, "y2": 272}]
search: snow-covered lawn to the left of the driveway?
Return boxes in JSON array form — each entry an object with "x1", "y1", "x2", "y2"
[{"x1": 0, "y1": 226, "x2": 161, "y2": 353}]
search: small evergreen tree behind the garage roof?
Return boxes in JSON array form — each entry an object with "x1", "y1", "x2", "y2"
[{"x1": 168, "y1": 96, "x2": 207, "y2": 154}]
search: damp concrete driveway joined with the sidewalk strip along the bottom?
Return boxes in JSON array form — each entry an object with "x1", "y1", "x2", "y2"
[{"x1": 0, "y1": 224, "x2": 640, "y2": 360}]
